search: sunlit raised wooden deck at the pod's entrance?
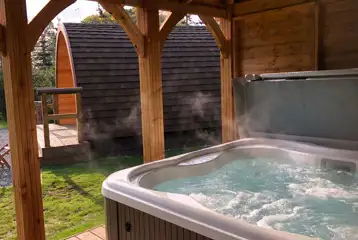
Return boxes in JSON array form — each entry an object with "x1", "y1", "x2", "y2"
[{"x1": 37, "y1": 124, "x2": 90, "y2": 164}]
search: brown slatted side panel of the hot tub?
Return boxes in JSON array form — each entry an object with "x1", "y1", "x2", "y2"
[{"x1": 106, "y1": 199, "x2": 210, "y2": 240}]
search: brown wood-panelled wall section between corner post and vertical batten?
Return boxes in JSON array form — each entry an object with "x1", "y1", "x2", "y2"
[{"x1": 235, "y1": 3, "x2": 317, "y2": 76}]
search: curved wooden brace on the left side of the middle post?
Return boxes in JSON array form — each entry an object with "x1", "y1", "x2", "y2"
[{"x1": 99, "y1": 0, "x2": 145, "y2": 56}]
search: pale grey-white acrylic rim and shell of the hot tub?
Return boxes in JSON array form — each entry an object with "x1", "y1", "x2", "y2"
[{"x1": 102, "y1": 139, "x2": 358, "y2": 240}]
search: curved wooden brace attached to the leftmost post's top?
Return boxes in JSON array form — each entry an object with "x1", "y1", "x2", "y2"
[{"x1": 27, "y1": 0, "x2": 76, "y2": 52}]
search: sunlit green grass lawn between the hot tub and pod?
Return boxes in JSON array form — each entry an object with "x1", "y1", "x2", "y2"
[{"x1": 0, "y1": 148, "x2": 198, "y2": 239}]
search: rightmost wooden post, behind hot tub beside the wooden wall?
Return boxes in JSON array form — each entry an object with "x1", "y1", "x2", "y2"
[{"x1": 220, "y1": 19, "x2": 238, "y2": 143}]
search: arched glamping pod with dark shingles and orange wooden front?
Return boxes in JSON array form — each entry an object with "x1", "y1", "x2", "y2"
[{"x1": 56, "y1": 23, "x2": 221, "y2": 153}]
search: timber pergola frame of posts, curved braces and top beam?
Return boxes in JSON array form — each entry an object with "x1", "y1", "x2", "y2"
[{"x1": 0, "y1": 0, "x2": 314, "y2": 240}]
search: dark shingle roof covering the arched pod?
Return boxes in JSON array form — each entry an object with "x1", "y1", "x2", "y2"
[{"x1": 64, "y1": 23, "x2": 221, "y2": 139}]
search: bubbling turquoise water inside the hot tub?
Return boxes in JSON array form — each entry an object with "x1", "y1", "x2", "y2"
[{"x1": 154, "y1": 158, "x2": 358, "y2": 240}]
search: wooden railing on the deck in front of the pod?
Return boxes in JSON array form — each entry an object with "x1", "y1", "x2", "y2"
[{"x1": 37, "y1": 87, "x2": 83, "y2": 148}]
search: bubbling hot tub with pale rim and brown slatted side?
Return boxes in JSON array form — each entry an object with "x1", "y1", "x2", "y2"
[{"x1": 102, "y1": 138, "x2": 358, "y2": 240}]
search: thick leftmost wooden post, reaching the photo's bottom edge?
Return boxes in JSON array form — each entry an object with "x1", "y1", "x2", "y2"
[{"x1": 0, "y1": 0, "x2": 45, "y2": 240}]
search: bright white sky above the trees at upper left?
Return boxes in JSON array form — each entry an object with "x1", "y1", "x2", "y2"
[{"x1": 26, "y1": 0, "x2": 97, "y2": 24}]
